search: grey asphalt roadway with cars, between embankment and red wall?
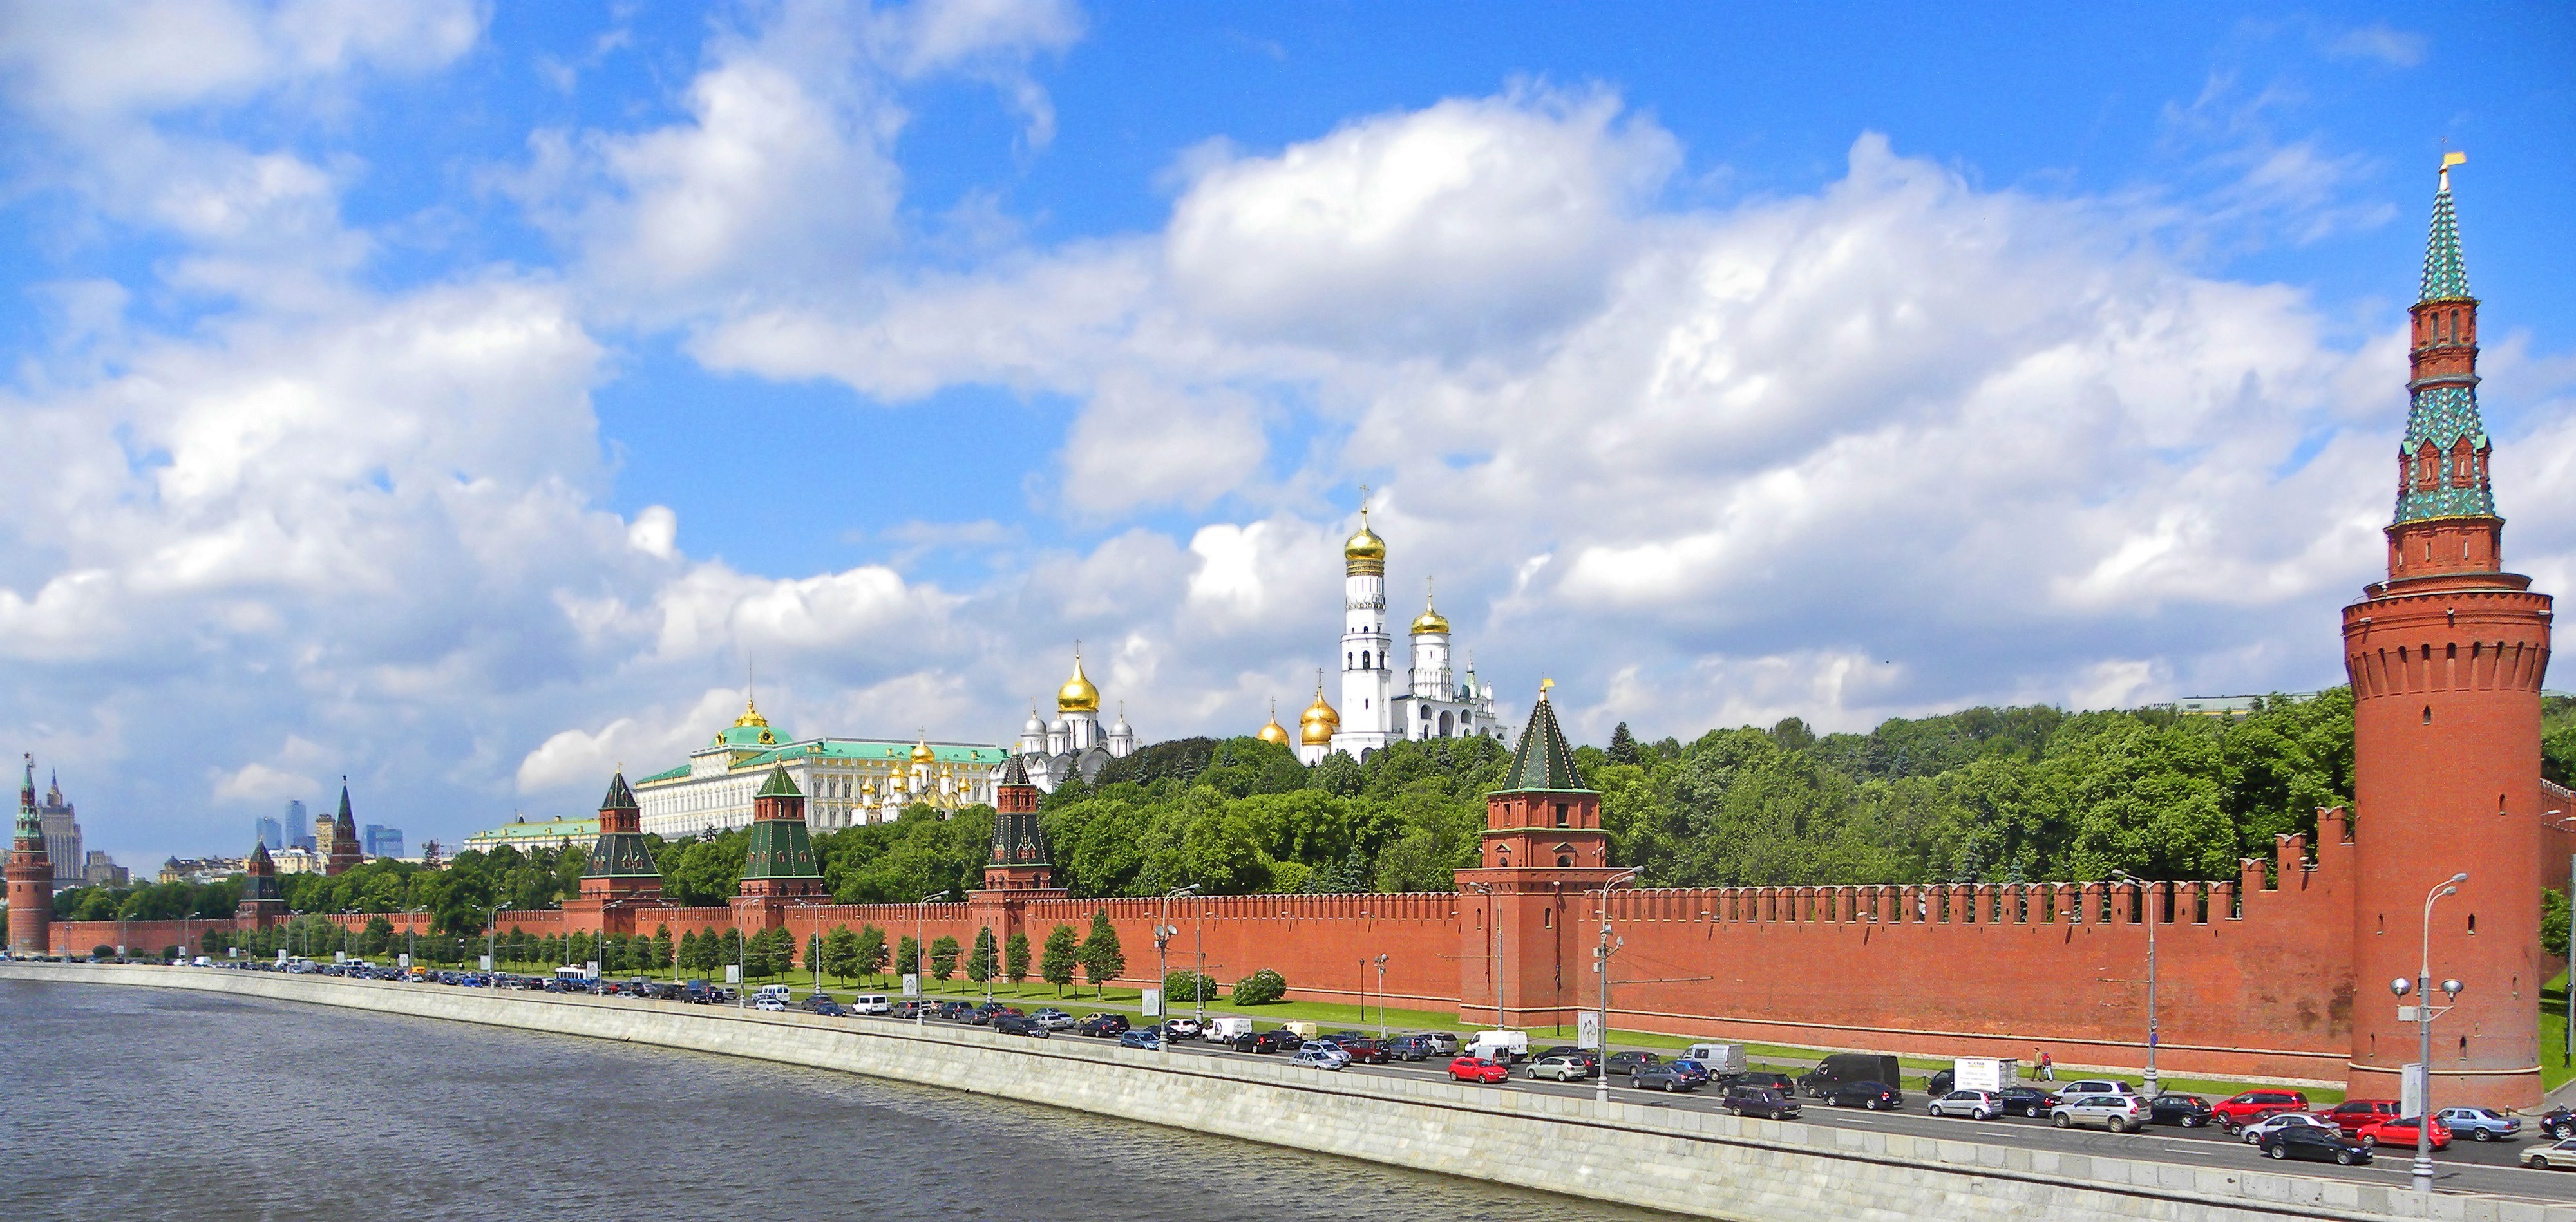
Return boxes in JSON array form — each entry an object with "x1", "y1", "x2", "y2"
[{"x1": 1005, "y1": 1031, "x2": 2576, "y2": 1201}]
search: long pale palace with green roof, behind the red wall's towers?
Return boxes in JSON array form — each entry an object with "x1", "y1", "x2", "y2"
[{"x1": 634, "y1": 696, "x2": 1010, "y2": 838}]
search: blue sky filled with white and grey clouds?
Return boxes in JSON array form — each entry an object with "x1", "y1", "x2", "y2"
[{"x1": 0, "y1": 0, "x2": 2576, "y2": 858}]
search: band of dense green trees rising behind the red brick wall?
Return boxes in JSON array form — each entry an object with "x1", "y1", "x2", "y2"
[{"x1": 57, "y1": 688, "x2": 2576, "y2": 934}]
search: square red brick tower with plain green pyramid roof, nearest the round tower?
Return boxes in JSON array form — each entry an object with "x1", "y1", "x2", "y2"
[{"x1": 1458, "y1": 683, "x2": 1618, "y2": 1026}]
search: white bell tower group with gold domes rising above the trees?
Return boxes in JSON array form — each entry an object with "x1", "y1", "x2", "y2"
[{"x1": 1262, "y1": 505, "x2": 1504, "y2": 766}]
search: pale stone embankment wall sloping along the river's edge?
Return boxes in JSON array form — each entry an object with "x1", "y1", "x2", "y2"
[{"x1": 0, "y1": 964, "x2": 2545, "y2": 1222}]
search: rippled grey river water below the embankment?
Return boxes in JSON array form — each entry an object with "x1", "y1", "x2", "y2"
[{"x1": 0, "y1": 980, "x2": 1667, "y2": 1222}]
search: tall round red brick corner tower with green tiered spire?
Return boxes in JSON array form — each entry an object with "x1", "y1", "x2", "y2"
[{"x1": 2344, "y1": 160, "x2": 2550, "y2": 1106}]
